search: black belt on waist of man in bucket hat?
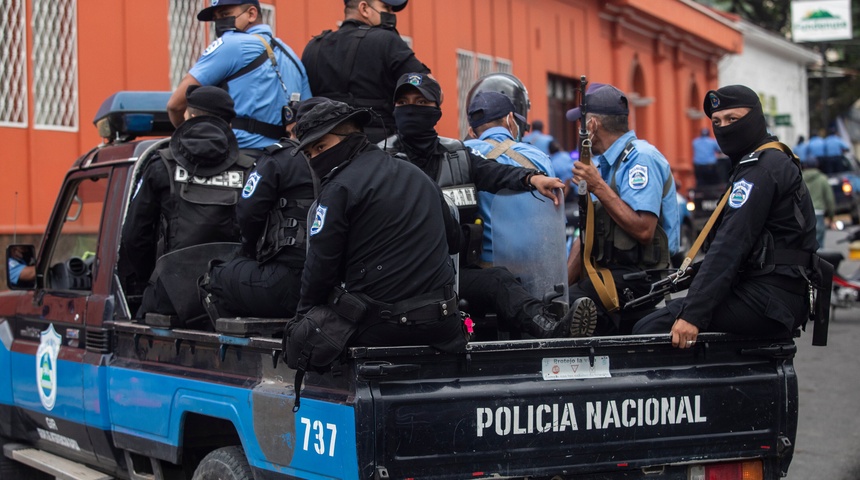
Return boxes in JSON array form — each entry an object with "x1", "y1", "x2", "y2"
[{"x1": 361, "y1": 285, "x2": 459, "y2": 325}]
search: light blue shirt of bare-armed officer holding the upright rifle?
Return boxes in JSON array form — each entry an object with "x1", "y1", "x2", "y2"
[{"x1": 594, "y1": 130, "x2": 681, "y2": 255}]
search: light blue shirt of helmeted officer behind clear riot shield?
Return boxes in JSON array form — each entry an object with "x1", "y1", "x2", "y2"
[{"x1": 465, "y1": 127, "x2": 555, "y2": 263}]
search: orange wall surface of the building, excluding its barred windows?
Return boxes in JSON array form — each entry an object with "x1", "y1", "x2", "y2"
[{"x1": 0, "y1": 0, "x2": 742, "y2": 234}]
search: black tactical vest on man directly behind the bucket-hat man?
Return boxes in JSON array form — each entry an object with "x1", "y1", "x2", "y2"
[{"x1": 257, "y1": 140, "x2": 315, "y2": 268}]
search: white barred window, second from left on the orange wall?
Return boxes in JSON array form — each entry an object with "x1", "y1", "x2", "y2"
[{"x1": 31, "y1": 0, "x2": 78, "y2": 131}]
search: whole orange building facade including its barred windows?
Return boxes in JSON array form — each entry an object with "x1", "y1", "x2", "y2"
[{"x1": 0, "y1": 0, "x2": 740, "y2": 244}]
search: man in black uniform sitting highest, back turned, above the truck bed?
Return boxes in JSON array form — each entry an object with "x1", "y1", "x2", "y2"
[{"x1": 302, "y1": 0, "x2": 430, "y2": 143}]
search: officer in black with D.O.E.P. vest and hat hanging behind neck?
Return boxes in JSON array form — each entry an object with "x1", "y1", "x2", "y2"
[{"x1": 121, "y1": 85, "x2": 254, "y2": 317}]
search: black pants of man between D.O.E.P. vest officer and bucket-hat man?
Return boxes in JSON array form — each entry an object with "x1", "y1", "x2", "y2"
[{"x1": 206, "y1": 257, "x2": 302, "y2": 318}]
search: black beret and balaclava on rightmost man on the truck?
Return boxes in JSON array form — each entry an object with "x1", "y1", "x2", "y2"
[{"x1": 704, "y1": 85, "x2": 769, "y2": 163}]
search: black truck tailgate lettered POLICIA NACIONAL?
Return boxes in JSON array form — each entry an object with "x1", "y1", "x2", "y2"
[{"x1": 356, "y1": 334, "x2": 797, "y2": 478}]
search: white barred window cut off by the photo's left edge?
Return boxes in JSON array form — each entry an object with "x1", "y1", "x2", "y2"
[{"x1": 0, "y1": 0, "x2": 27, "y2": 127}]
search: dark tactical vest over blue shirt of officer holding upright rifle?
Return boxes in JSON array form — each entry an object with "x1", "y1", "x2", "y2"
[{"x1": 593, "y1": 140, "x2": 673, "y2": 269}]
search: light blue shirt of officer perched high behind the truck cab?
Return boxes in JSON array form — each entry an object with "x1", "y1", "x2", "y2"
[{"x1": 188, "y1": 24, "x2": 311, "y2": 148}]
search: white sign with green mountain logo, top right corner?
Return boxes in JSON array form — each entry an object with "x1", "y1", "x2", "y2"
[{"x1": 791, "y1": 0, "x2": 853, "y2": 42}]
